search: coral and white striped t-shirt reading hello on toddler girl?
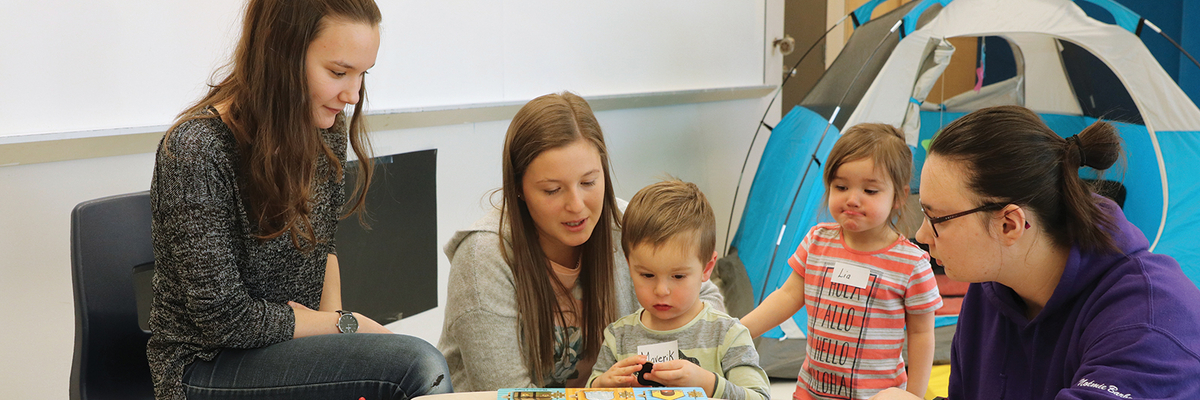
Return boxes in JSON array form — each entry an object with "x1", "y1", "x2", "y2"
[{"x1": 787, "y1": 223, "x2": 942, "y2": 399}]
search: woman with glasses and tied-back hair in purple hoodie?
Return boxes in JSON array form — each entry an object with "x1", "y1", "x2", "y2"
[{"x1": 872, "y1": 106, "x2": 1200, "y2": 400}]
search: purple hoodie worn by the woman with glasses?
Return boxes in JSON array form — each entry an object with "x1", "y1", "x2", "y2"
[{"x1": 949, "y1": 198, "x2": 1200, "y2": 400}]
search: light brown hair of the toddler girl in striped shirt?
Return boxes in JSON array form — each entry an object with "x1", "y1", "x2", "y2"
[{"x1": 824, "y1": 124, "x2": 912, "y2": 232}]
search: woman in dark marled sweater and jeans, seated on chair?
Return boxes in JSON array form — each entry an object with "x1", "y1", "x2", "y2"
[{"x1": 146, "y1": 0, "x2": 451, "y2": 399}]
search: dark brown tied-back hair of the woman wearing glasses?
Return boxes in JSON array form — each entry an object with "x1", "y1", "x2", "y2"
[{"x1": 929, "y1": 106, "x2": 1121, "y2": 251}]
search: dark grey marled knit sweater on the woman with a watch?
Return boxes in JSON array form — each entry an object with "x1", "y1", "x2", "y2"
[{"x1": 146, "y1": 109, "x2": 346, "y2": 399}]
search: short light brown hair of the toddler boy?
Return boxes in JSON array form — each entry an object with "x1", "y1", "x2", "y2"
[{"x1": 620, "y1": 178, "x2": 716, "y2": 264}]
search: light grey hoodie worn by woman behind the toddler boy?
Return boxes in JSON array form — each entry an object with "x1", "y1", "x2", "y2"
[{"x1": 438, "y1": 199, "x2": 725, "y2": 392}]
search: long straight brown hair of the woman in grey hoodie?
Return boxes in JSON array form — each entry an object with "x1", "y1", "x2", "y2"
[{"x1": 500, "y1": 92, "x2": 620, "y2": 386}]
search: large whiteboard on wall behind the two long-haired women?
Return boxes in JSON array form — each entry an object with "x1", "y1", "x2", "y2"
[{"x1": 0, "y1": 0, "x2": 768, "y2": 138}]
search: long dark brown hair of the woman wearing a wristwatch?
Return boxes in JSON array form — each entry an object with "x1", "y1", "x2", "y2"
[{"x1": 167, "y1": 0, "x2": 382, "y2": 249}]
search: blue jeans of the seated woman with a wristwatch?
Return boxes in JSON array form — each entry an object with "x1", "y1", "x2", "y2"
[{"x1": 184, "y1": 334, "x2": 454, "y2": 400}]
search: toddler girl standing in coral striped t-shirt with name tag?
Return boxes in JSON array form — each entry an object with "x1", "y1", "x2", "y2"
[{"x1": 742, "y1": 124, "x2": 942, "y2": 399}]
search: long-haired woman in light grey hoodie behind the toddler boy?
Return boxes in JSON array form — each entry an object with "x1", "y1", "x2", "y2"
[{"x1": 438, "y1": 92, "x2": 725, "y2": 390}]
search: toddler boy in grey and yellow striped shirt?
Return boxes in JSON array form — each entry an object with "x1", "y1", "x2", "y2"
[{"x1": 588, "y1": 179, "x2": 770, "y2": 400}]
